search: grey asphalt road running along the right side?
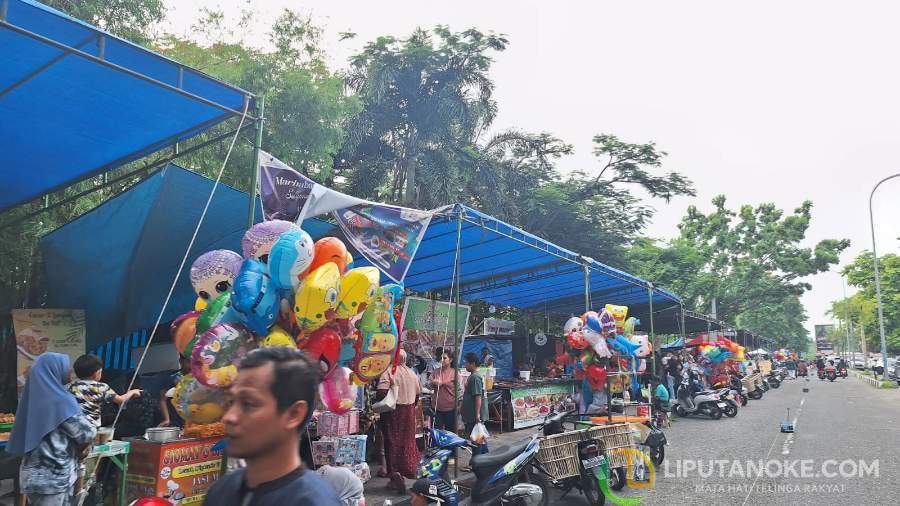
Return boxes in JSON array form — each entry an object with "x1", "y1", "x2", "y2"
[{"x1": 551, "y1": 377, "x2": 900, "y2": 506}]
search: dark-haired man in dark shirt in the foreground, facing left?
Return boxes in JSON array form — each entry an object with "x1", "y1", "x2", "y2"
[{"x1": 204, "y1": 347, "x2": 341, "y2": 506}]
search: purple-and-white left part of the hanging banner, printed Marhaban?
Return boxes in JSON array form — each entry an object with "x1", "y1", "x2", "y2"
[{"x1": 259, "y1": 151, "x2": 365, "y2": 223}]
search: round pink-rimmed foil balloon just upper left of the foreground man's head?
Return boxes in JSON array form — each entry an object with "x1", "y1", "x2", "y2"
[{"x1": 191, "y1": 323, "x2": 256, "y2": 388}]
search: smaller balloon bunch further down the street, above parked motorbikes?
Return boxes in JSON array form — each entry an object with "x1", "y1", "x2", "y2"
[{"x1": 556, "y1": 304, "x2": 653, "y2": 390}]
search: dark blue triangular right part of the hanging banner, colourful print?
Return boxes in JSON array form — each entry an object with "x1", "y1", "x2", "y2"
[{"x1": 334, "y1": 204, "x2": 432, "y2": 283}]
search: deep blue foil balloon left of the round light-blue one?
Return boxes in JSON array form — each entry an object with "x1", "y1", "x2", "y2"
[{"x1": 231, "y1": 259, "x2": 279, "y2": 336}]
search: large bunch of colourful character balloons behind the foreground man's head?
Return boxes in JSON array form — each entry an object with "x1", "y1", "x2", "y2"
[{"x1": 171, "y1": 220, "x2": 403, "y2": 423}]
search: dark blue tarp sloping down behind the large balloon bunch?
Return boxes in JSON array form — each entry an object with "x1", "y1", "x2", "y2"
[{"x1": 41, "y1": 165, "x2": 331, "y2": 349}]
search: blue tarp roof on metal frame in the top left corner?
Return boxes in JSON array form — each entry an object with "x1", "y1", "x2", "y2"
[{"x1": 0, "y1": 0, "x2": 252, "y2": 211}]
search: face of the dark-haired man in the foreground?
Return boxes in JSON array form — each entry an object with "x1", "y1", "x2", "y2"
[{"x1": 222, "y1": 363, "x2": 307, "y2": 459}]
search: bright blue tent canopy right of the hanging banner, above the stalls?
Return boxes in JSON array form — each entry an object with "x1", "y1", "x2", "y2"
[{"x1": 405, "y1": 205, "x2": 681, "y2": 320}]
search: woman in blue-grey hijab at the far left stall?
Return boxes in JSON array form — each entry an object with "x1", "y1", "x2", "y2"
[{"x1": 6, "y1": 352, "x2": 97, "y2": 506}]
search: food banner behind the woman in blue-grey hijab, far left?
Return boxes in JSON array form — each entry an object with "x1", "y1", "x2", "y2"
[{"x1": 12, "y1": 309, "x2": 85, "y2": 395}]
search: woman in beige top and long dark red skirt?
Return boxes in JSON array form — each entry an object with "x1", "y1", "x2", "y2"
[{"x1": 376, "y1": 350, "x2": 422, "y2": 494}]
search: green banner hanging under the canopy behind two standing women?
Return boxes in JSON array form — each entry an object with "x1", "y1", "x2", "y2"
[{"x1": 401, "y1": 297, "x2": 471, "y2": 357}]
